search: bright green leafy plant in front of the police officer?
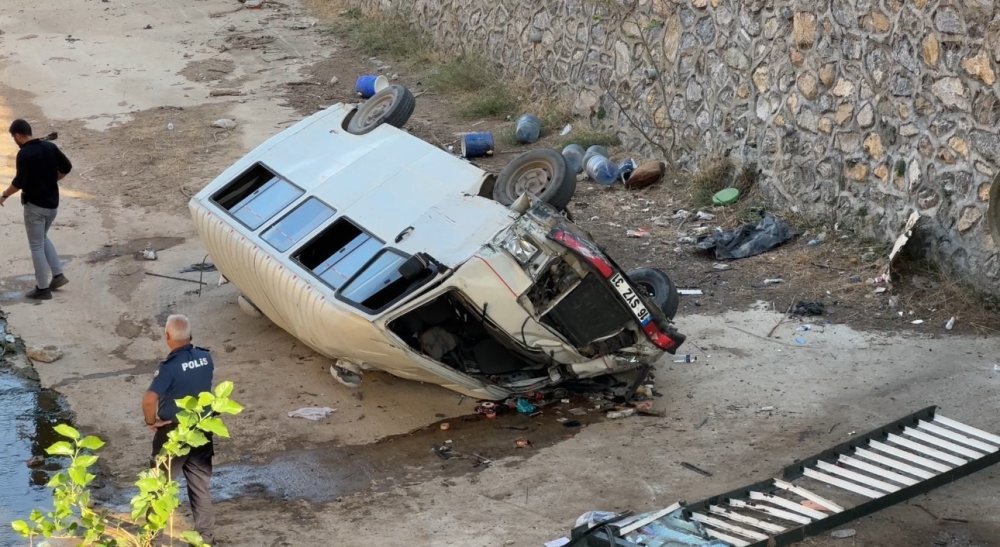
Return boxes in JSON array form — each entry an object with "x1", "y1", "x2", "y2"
[{"x1": 11, "y1": 381, "x2": 243, "y2": 547}]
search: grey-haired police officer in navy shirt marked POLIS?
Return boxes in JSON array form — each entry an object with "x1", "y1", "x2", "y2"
[{"x1": 142, "y1": 315, "x2": 215, "y2": 543}]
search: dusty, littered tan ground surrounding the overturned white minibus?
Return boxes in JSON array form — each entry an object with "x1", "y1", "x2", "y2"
[{"x1": 0, "y1": 0, "x2": 1000, "y2": 546}]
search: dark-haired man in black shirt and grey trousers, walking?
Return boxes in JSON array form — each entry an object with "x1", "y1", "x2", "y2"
[{"x1": 0, "y1": 119, "x2": 73, "y2": 300}]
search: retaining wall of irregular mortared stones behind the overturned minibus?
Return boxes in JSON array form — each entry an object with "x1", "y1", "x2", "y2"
[{"x1": 347, "y1": 0, "x2": 1000, "y2": 292}]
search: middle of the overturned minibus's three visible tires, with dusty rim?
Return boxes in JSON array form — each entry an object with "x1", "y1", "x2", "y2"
[{"x1": 493, "y1": 148, "x2": 576, "y2": 211}]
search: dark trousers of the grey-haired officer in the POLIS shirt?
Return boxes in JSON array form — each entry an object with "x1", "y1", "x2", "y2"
[{"x1": 153, "y1": 425, "x2": 215, "y2": 543}]
